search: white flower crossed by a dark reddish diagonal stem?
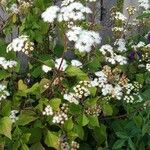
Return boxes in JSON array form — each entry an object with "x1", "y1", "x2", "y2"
[{"x1": 55, "y1": 58, "x2": 68, "y2": 71}]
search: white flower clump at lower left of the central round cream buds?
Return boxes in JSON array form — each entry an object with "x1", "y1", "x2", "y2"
[{"x1": 64, "y1": 93, "x2": 79, "y2": 105}]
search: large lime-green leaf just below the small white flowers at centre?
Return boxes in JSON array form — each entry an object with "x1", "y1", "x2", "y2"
[{"x1": 66, "y1": 66, "x2": 89, "y2": 81}]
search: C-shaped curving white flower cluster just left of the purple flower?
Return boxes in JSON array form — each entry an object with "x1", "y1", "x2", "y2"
[{"x1": 100, "y1": 44, "x2": 127, "y2": 65}]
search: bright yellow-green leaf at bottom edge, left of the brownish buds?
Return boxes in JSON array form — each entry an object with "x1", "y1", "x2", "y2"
[{"x1": 44, "y1": 130, "x2": 59, "y2": 149}]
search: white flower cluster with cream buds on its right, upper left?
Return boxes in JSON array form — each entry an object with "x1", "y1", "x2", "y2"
[{"x1": 7, "y1": 35, "x2": 34, "y2": 55}]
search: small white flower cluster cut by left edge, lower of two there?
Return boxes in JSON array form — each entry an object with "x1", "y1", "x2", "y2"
[{"x1": 0, "y1": 84, "x2": 10, "y2": 101}]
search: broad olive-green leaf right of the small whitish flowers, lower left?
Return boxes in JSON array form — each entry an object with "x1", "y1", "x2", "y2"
[{"x1": 16, "y1": 111, "x2": 38, "y2": 126}]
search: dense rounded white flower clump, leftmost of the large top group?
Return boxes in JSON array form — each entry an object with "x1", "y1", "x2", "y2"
[{"x1": 42, "y1": 6, "x2": 60, "y2": 23}]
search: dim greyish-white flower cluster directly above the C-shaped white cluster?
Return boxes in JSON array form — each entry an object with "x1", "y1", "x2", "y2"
[{"x1": 114, "y1": 39, "x2": 127, "y2": 52}]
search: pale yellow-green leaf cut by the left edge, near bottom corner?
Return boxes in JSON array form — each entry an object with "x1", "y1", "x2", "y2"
[{"x1": 0, "y1": 117, "x2": 12, "y2": 139}]
